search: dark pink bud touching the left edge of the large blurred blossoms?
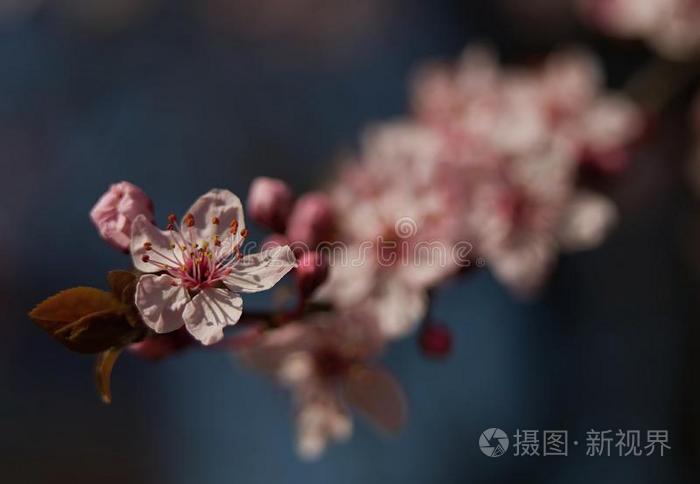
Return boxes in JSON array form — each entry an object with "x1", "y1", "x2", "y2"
[{"x1": 287, "y1": 192, "x2": 333, "y2": 249}]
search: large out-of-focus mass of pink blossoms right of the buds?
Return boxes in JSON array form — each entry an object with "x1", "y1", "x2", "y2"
[{"x1": 317, "y1": 47, "x2": 644, "y2": 302}]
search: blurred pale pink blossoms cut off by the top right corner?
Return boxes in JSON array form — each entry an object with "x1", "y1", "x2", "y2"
[{"x1": 579, "y1": 0, "x2": 700, "y2": 60}]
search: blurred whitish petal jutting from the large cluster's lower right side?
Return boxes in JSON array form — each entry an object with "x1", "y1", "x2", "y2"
[{"x1": 558, "y1": 191, "x2": 617, "y2": 251}]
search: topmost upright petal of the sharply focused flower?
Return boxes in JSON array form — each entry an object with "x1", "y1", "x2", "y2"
[{"x1": 187, "y1": 189, "x2": 245, "y2": 240}]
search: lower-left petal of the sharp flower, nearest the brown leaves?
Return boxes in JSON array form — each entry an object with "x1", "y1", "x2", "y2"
[{"x1": 135, "y1": 274, "x2": 189, "y2": 333}]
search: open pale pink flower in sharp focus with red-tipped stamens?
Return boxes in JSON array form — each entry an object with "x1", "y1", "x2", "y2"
[{"x1": 131, "y1": 190, "x2": 295, "y2": 345}]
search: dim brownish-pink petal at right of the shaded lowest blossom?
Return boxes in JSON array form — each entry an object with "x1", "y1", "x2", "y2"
[{"x1": 342, "y1": 368, "x2": 406, "y2": 434}]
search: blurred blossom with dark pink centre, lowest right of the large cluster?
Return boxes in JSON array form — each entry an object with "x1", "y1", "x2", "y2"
[{"x1": 467, "y1": 154, "x2": 617, "y2": 296}]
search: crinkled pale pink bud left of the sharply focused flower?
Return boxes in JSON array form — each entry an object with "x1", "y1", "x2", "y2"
[{"x1": 90, "y1": 181, "x2": 154, "y2": 252}]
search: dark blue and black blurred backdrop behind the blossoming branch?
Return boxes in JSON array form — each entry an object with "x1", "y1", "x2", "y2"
[{"x1": 0, "y1": 0, "x2": 700, "y2": 484}]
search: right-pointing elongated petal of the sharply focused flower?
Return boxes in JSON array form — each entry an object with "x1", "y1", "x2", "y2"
[{"x1": 224, "y1": 245, "x2": 296, "y2": 292}]
